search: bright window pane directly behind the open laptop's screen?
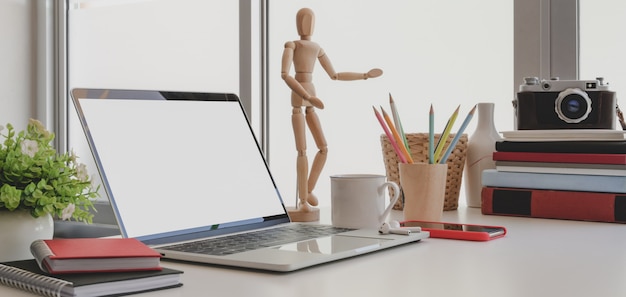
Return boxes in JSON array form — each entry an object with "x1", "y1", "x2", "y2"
[{"x1": 68, "y1": 0, "x2": 239, "y2": 199}]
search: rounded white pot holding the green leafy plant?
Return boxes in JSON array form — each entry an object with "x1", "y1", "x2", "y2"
[{"x1": 0, "y1": 210, "x2": 54, "y2": 262}]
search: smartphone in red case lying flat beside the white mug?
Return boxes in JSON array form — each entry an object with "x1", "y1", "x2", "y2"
[{"x1": 400, "y1": 220, "x2": 506, "y2": 241}]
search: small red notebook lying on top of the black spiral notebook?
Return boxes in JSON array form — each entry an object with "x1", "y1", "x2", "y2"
[{"x1": 30, "y1": 238, "x2": 162, "y2": 273}]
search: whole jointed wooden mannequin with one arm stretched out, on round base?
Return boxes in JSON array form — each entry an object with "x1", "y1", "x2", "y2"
[{"x1": 281, "y1": 8, "x2": 383, "y2": 222}]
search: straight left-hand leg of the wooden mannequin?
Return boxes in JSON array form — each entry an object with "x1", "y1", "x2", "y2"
[{"x1": 291, "y1": 107, "x2": 309, "y2": 212}]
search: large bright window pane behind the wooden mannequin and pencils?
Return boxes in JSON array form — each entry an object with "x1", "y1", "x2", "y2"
[{"x1": 268, "y1": 0, "x2": 513, "y2": 205}]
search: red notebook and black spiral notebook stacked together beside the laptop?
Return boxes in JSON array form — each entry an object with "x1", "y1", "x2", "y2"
[{"x1": 0, "y1": 238, "x2": 182, "y2": 297}]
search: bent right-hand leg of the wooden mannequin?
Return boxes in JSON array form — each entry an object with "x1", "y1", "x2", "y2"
[{"x1": 306, "y1": 107, "x2": 328, "y2": 206}]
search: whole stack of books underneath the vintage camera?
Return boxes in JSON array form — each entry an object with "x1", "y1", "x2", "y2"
[{"x1": 481, "y1": 130, "x2": 626, "y2": 223}]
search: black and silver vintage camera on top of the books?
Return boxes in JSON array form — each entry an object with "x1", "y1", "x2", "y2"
[{"x1": 513, "y1": 77, "x2": 617, "y2": 130}]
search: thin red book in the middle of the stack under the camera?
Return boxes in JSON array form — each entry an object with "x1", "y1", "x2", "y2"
[{"x1": 493, "y1": 152, "x2": 626, "y2": 165}]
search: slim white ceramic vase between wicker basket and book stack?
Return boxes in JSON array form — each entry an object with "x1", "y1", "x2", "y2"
[{"x1": 463, "y1": 102, "x2": 502, "y2": 207}]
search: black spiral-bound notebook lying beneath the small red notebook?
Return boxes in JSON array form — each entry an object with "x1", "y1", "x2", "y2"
[{"x1": 0, "y1": 260, "x2": 183, "y2": 297}]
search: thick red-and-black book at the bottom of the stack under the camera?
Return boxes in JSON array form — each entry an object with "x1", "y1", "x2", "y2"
[{"x1": 481, "y1": 187, "x2": 626, "y2": 223}]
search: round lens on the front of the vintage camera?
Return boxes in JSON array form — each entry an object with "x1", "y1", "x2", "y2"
[{"x1": 554, "y1": 89, "x2": 591, "y2": 123}]
